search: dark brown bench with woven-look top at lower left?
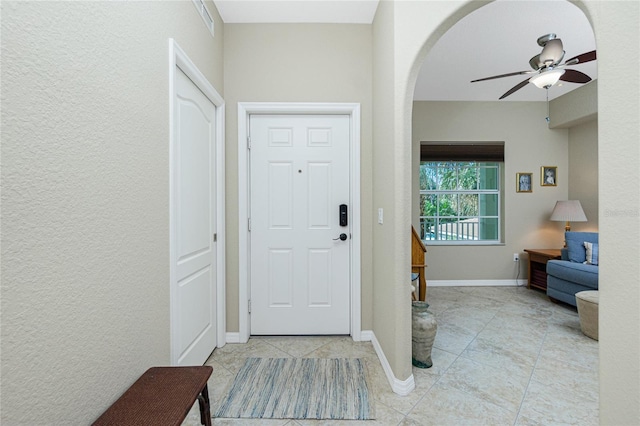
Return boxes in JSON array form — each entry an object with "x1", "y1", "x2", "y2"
[{"x1": 93, "y1": 365, "x2": 213, "y2": 426}]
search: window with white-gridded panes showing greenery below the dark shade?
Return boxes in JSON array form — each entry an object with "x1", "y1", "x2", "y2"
[{"x1": 420, "y1": 146, "x2": 503, "y2": 244}]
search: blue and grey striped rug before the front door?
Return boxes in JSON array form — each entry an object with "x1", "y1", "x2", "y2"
[{"x1": 214, "y1": 358, "x2": 375, "y2": 420}]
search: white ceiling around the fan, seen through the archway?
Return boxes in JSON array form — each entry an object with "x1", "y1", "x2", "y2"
[{"x1": 414, "y1": 0, "x2": 597, "y2": 102}]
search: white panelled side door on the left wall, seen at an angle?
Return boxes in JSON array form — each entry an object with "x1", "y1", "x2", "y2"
[{"x1": 171, "y1": 67, "x2": 216, "y2": 365}]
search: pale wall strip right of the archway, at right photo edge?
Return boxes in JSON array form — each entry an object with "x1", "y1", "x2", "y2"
[{"x1": 585, "y1": 1, "x2": 640, "y2": 425}]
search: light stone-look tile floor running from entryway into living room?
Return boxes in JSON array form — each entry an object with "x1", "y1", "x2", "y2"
[{"x1": 184, "y1": 287, "x2": 598, "y2": 426}]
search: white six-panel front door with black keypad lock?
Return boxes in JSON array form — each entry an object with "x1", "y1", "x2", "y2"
[{"x1": 249, "y1": 115, "x2": 351, "y2": 334}]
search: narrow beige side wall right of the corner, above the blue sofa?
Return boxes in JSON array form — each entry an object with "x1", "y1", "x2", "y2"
[{"x1": 568, "y1": 120, "x2": 599, "y2": 232}]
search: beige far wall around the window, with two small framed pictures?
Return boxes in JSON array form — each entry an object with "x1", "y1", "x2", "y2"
[{"x1": 412, "y1": 102, "x2": 569, "y2": 284}]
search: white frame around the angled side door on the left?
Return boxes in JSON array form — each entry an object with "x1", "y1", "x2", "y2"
[{"x1": 169, "y1": 38, "x2": 227, "y2": 365}]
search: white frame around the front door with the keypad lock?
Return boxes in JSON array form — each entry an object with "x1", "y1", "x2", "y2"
[{"x1": 238, "y1": 102, "x2": 362, "y2": 343}]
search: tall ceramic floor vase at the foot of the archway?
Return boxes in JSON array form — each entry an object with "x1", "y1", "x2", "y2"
[{"x1": 411, "y1": 301, "x2": 438, "y2": 368}]
